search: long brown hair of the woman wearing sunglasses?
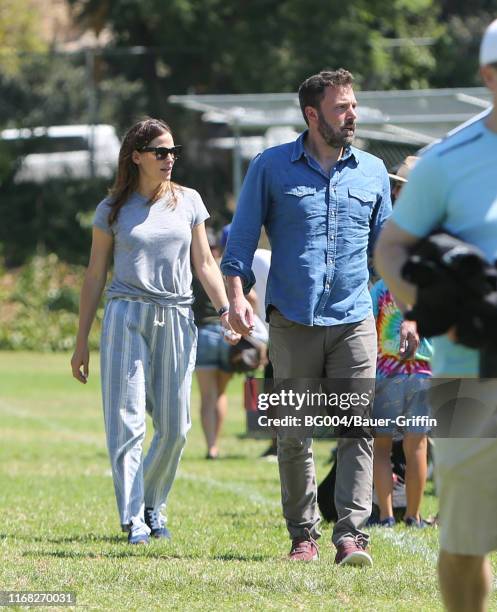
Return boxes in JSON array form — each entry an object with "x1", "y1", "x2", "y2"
[{"x1": 109, "y1": 118, "x2": 179, "y2": 225}]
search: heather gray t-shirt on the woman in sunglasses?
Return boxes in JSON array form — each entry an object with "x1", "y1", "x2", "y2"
[{"x1": 93, "y1": 187, "x2": 209, "y2": 306}]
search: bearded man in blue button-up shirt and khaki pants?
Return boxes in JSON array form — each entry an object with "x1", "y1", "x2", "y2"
[{"x1": 221, "y1": 68, "x2": 391, "y2": 565}]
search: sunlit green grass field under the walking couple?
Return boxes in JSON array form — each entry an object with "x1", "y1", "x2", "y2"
[{"x1": 0, "y1": 353, "x2": 497, "y2": 611}]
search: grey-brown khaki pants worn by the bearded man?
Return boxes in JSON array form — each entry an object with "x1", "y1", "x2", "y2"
[{"x1": 269, "y1": 309, "x2": 377, "y2": 545}]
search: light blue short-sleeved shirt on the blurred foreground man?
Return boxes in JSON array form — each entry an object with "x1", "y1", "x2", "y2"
[{"x1": 392, "y1": 112, "x2": 497, "y2": 376}]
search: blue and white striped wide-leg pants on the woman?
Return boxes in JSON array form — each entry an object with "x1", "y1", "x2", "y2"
[{"x1": 100, "y1": 298, "x2": 197, "y2": 531}]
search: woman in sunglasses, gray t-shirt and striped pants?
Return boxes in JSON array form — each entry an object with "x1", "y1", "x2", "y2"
[{"x1": 71, "y1": 119, "x2": 239, "y2": 544}]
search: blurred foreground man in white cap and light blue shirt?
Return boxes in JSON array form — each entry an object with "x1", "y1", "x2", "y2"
[{"x1": 375, "y1": 20, "x2": 497, "y2": 612}]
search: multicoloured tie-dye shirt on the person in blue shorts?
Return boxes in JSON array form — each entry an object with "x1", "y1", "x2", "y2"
[{"x1": 371, "y1": 280, "x2": 433, "y2": 378}]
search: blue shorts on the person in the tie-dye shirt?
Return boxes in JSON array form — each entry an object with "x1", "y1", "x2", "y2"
[{"x1": 372, "y1": 374, "x2": 430, "y2": 436}]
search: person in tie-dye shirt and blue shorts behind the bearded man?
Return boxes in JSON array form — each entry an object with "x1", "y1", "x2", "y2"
[{"x1": 371, "y1": 280, "x2": 432, "y2": 527}]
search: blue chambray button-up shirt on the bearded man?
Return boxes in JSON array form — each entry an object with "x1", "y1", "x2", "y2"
[{"x1": 221, "y1": 132, "x2": 392, "y2": 325}]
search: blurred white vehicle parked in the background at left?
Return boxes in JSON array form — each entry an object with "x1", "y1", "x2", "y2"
[{"x1": 0, "y1": 124, "x2": 120, "y2": 183}]
